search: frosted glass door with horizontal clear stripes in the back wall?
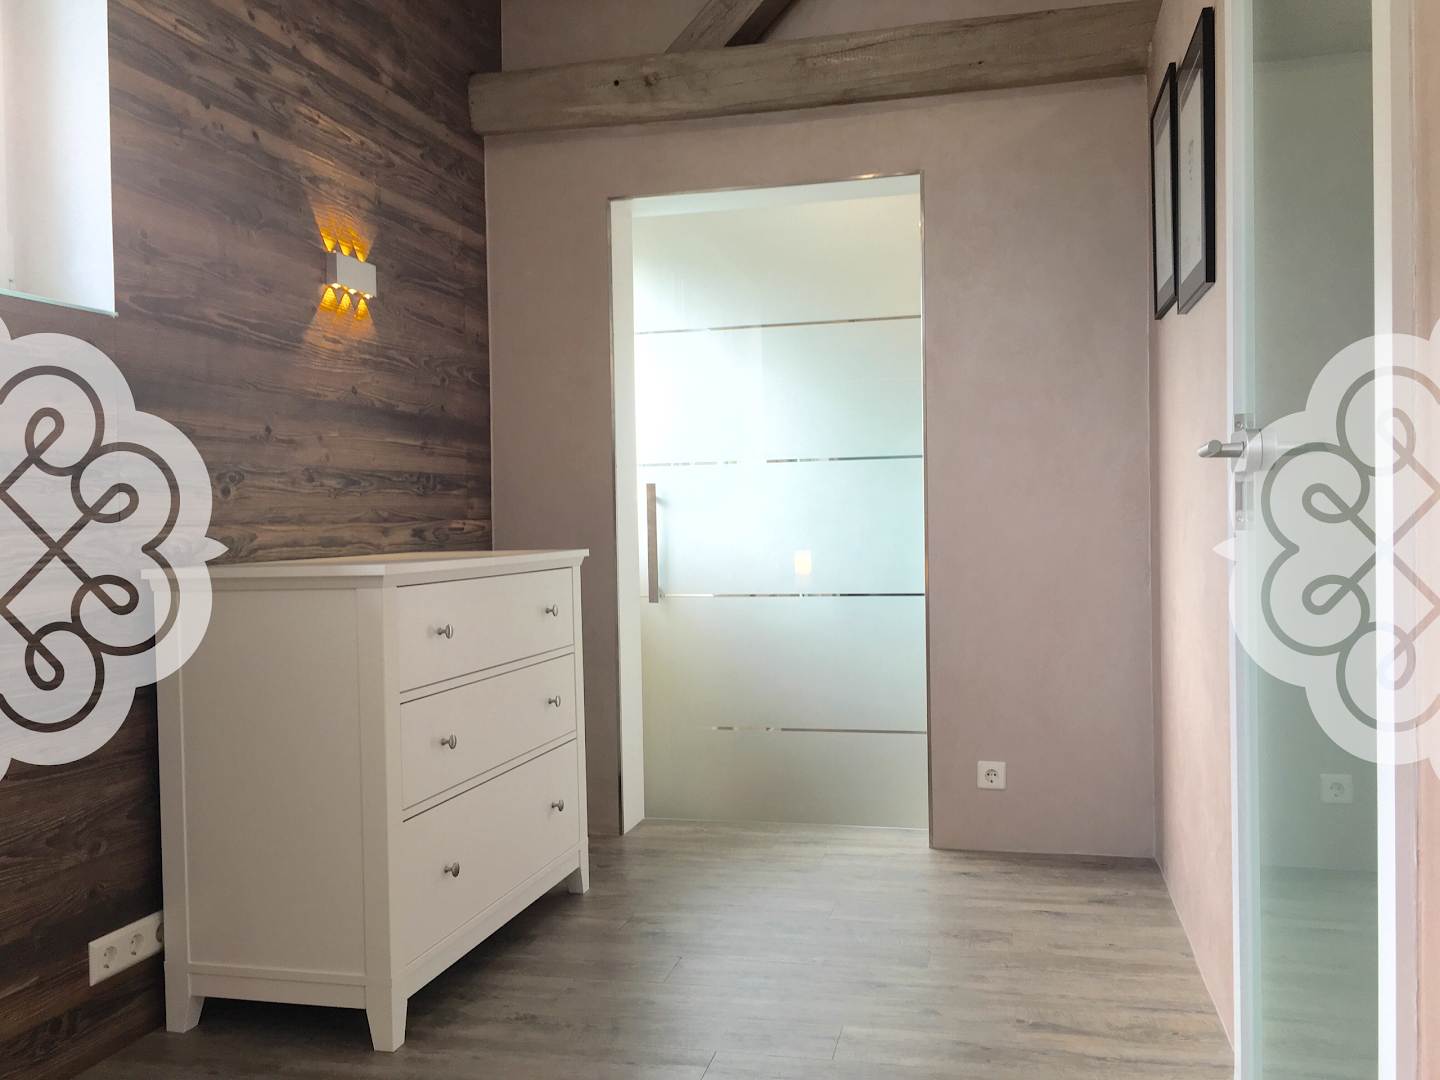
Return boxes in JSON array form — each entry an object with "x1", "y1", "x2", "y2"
[{"x1": 634, "y1": 180, "x2": 929, "y2": 828}]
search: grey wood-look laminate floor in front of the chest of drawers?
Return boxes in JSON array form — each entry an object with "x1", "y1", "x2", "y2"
[{"x1": 78, "y1": 822, "x2": 1231, "y2": 1080}]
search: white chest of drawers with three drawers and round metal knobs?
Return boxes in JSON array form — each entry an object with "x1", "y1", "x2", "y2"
[{"x1": 160, "y1": 552, "x2": 589, "y2": 1050}]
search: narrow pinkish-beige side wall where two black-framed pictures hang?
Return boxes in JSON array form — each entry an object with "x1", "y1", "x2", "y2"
[{"x1": 1149, "y1": 0, "x2": 1234, "y2": 1037}]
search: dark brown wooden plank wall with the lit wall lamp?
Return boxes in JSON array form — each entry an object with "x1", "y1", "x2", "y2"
[{"x1": 0, "y1": 0, "x2": 500, "y2": 1080}]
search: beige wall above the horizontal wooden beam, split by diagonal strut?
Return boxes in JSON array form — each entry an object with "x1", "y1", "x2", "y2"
[{"x1": 501, "y1": 0, "x2": 1106, "y2": 71}]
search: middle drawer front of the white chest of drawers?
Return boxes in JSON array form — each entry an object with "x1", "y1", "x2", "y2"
[{"x1": 400, "y1": 655, "x2": 575, "y2": 806}]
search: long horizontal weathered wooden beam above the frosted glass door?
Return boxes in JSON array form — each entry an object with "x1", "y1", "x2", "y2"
[{"x1": 469, "y1": 0, "x2": 1161, "y2": 135}]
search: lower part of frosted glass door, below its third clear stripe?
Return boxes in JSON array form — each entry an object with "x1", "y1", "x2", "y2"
[{"x1": 641, "y1": 596, "x2": 929, "y2": 828}]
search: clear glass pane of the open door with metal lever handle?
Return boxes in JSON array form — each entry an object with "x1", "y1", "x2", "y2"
[{"x1": 1236, "y1": 0, "x2": 1380, "y2": 1080}]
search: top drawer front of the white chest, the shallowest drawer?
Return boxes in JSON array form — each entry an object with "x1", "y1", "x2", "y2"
[{"x1": 396, "y1": 567, "x2": 575, "y2": 690}]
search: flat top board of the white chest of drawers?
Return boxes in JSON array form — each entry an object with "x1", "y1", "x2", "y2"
[{"x1": 209, "y1": 549, "x2": 589, "y2": 585}]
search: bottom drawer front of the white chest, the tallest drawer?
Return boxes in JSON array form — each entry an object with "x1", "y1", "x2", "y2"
[{"x1": 396, "y1": 742, "x2": 580, "y2": 963}]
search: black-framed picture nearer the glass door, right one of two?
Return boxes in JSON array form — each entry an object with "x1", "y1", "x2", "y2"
[{"x1": 1175, "y1": 7, "x2": 1215, "y2": 314}]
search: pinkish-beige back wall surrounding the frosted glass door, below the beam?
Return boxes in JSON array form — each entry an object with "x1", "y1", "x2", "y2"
[{"x1": 485, "y1": 78, "x2": 1157, "y2": 855}]
